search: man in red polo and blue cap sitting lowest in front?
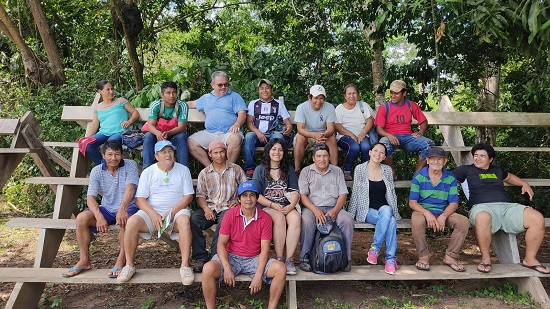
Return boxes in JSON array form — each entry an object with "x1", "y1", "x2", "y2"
[{"x1": 202, "y1": 181, "x2": 286, "y2": 309}]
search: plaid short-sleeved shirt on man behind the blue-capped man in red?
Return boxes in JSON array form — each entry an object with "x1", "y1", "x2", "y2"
[{"x1": 196, "y1": 161, "x2": 246, "y2": 212}]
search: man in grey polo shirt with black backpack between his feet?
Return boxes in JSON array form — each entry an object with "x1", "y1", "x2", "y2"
[{"x1": 298, "y1": 144, "x2": 353, "y2": 271}]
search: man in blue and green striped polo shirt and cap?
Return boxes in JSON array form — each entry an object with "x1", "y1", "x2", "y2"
[{"x1": 409, "y1": 147, "x2": 470, "y2": 272}]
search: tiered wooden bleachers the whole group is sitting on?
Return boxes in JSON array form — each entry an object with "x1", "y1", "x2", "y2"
[{"x1": 0, "y1": 97, "x2": 550, "y2": 308}]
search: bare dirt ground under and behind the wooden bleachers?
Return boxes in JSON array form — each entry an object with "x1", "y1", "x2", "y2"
[{"x1": 0, "y1": 208, "x2": 550, "y2": 309}]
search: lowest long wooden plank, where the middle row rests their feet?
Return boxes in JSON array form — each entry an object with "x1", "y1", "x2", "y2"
[{"x1": 0, "y1": 264, "x2": 545, "y2": 284}]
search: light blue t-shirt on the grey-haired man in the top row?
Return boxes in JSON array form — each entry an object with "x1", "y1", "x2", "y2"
[{"x1": 196, "y1": 90, "x2": 247, "y2": 133}]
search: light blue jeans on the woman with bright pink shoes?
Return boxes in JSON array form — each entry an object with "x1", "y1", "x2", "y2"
[{"x1": 365, "y1": 205, "x2": 397, "y2": 261}]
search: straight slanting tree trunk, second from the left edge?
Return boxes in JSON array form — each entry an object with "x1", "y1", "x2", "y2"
[{"x1": 27, "y1": 0, "x2": 66, "y2": 85}]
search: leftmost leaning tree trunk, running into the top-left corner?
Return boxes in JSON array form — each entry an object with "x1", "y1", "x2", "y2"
[{"x1": 0, "y1": 3, "x2": 55, "y2": 85}]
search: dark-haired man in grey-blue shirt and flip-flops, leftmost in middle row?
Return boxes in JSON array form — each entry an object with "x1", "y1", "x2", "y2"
[{"x1": 63, "y1": 141, "x2": 139, "y2": 278}]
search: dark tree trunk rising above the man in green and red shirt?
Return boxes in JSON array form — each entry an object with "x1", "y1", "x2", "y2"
[{"x1": 111, "y1": 0, "x2": 143, "y2": 91}]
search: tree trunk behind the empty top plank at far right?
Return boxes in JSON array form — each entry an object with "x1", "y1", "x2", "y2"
[{"x1": 476, "y1": 62, "x2": 500, "y2": 146}]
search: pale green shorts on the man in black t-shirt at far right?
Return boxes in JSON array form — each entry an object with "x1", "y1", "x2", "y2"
[{"x1": 469, "y1": 202, "x2": 528, "y2": 234}]
